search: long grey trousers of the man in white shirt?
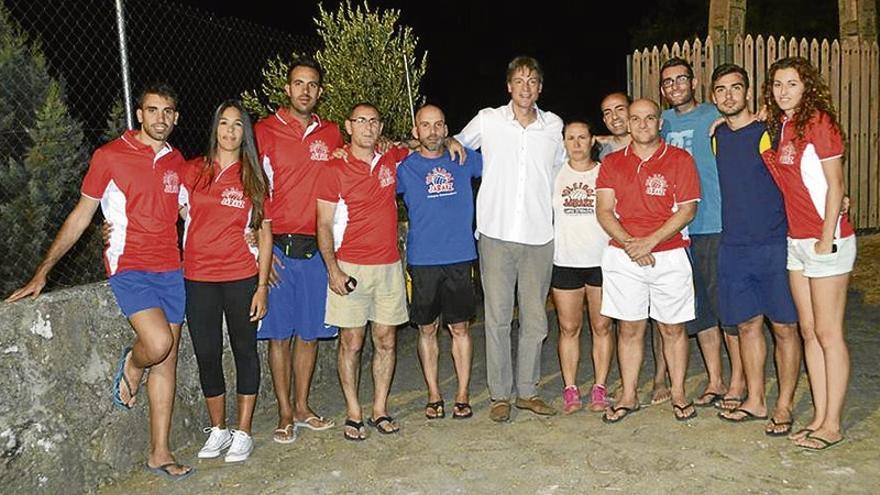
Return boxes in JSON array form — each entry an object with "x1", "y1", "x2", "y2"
[{"x1": 479, "y1": 236, "x2": 553, "y2": 400}]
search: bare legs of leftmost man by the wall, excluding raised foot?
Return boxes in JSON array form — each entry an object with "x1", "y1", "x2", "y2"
[{"x1": 129, "y1": 308, "x2": 192, "y2": 475}]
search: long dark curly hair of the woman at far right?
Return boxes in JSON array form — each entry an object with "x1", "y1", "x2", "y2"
[{"x1": 763, "y1": 57, "x2": 843, "y2": 147}]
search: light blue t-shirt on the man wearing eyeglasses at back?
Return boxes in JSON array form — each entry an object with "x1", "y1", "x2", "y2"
[{"x1": 660, "y1": 103, "x2": 721, "y2": 234}]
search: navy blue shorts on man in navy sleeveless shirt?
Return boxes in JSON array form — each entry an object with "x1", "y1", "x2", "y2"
[{"x1": 718, "y1": 239, "x2": 797, "y2": 325}]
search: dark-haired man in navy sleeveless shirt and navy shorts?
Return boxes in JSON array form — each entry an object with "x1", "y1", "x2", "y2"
[{"x1": 712, "y1": 64, "x2": 801, "y2": 436}]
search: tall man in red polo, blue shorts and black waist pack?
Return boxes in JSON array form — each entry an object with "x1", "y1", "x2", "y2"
[{"x1": 254, "y1": 58, "x2": 342, "y2": 443}]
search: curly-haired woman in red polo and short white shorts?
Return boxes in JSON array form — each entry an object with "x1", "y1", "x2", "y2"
[{"x1": 763, "y1": 57, "x2": 856, "y2": 450}]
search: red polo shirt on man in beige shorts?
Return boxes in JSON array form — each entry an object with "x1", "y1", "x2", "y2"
[{"x1": 318, "y1": 148, "x2": 409, "y2": 265}]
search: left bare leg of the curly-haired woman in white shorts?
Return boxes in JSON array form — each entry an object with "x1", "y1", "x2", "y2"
[{"x1": 788, "y1": 271, "x2": 826, "y2": 440}]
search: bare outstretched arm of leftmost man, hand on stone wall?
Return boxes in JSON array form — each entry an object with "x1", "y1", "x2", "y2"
[{"x1": 6, "y1": 195, "x2": 100, "y2": 302}]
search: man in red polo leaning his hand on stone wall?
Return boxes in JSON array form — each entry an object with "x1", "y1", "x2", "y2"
[{"x1": 7, "y1": 84, "x2": 193, "y2": 479}]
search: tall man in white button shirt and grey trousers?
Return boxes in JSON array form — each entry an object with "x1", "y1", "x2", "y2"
[{"x1": 456, "y1": 56, "x2": 565, "y2": 422}]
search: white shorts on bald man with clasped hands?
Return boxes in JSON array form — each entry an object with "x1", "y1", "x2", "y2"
[{"x1": 601, "y1": 246, "x2": 695, "y2": 325}]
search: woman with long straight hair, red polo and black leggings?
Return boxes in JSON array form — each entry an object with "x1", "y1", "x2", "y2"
[{"x1": 181, "y1": 100, "x2": 272, "y2": 462}]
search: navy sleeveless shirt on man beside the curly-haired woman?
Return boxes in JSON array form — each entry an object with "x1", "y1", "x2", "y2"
[{"x1": 715, "y1": 121, "x2": 788, "y2": 246}]
